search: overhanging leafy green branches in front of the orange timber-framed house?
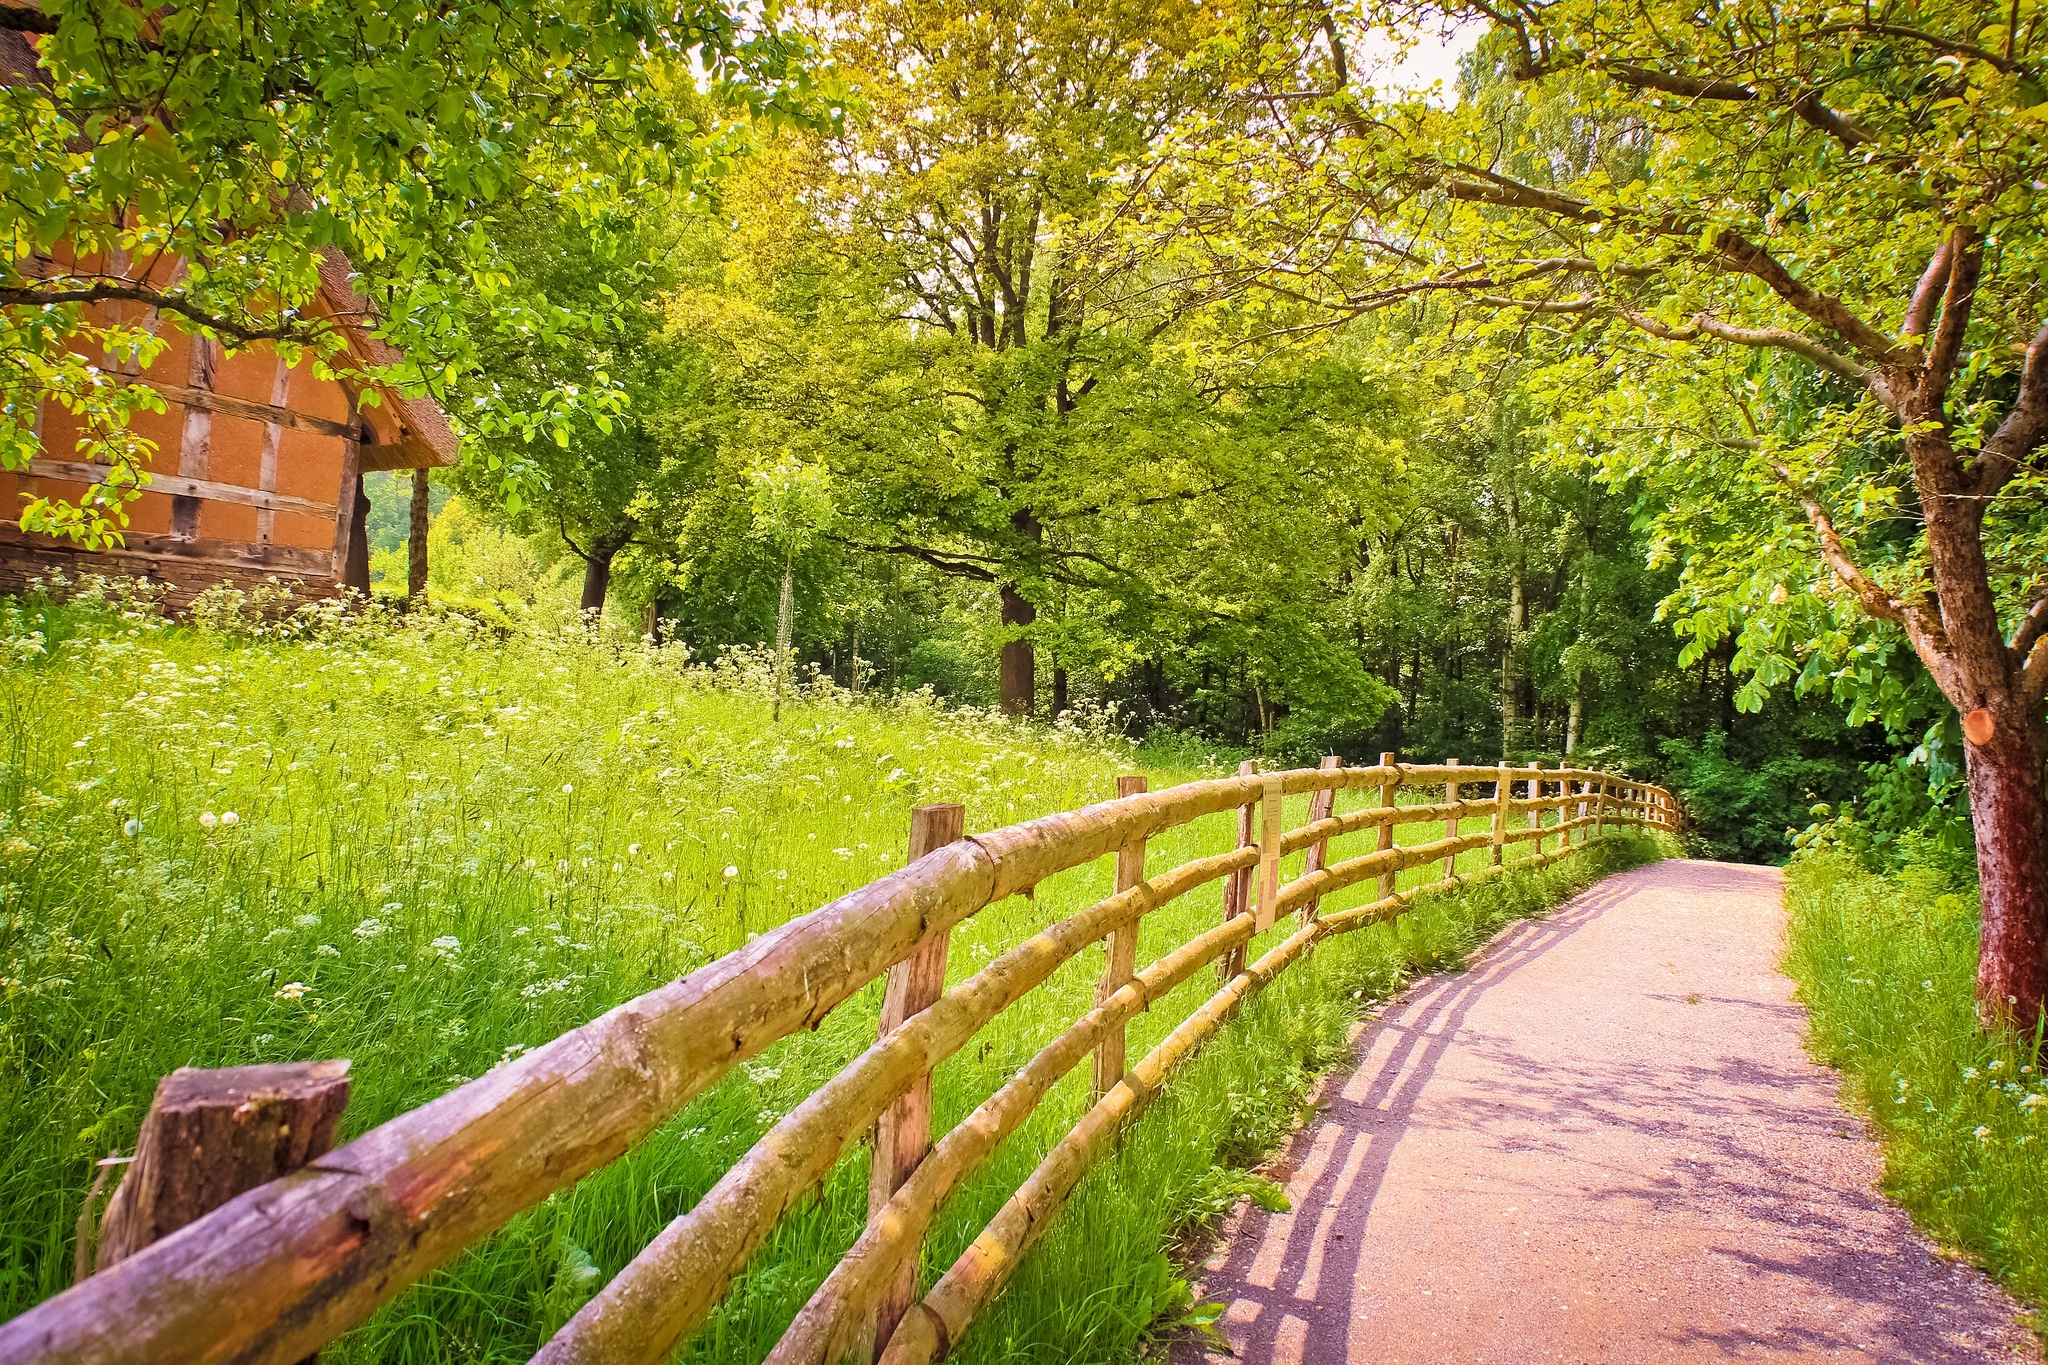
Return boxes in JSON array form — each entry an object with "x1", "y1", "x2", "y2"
[{"x1": 0, "y1": 0, "x2": 817, "y2": 544}]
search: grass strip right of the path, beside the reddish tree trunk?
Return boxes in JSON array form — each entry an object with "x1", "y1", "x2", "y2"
[{"x1": 1786, "y1": 849, "x2": 2048, "y2": 1308}]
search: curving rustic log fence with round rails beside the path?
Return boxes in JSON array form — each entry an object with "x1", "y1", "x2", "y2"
[{"x1": 0, "y1": 755, "x2": 1679, "y2": 1365}]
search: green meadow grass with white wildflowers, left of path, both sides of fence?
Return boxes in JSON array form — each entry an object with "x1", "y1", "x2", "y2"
[{"x1": 0, "y1": 600, "x2": 1653, "y2": 1363}]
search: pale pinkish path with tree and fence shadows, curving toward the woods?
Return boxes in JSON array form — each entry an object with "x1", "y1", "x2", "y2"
[{"x1": 1174, "y1": 862, "x2": 2038, "y2": 1365}]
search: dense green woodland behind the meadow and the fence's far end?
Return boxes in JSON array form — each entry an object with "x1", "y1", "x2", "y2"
[{"x1": 323, "y1": 2, "x2": 1970, "y2": 864}]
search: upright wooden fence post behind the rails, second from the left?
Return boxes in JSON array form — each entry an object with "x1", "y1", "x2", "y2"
[{"x1": 868, "y1": 804, "x2": 967, "y2": 1359}]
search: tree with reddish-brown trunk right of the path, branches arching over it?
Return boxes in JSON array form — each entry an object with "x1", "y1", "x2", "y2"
[{"x1": 1196, "y1": 0, "x2": 2048, "y2": 1027}]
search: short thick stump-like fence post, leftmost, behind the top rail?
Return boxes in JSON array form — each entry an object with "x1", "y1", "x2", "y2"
[{"x1": 93, "y1": 1060, "x2": 348, "y2": 1271}]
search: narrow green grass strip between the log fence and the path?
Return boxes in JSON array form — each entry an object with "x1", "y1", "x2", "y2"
[{"x1": 954, "y1": 837, "x2": 1667, "y2": 1365}]
